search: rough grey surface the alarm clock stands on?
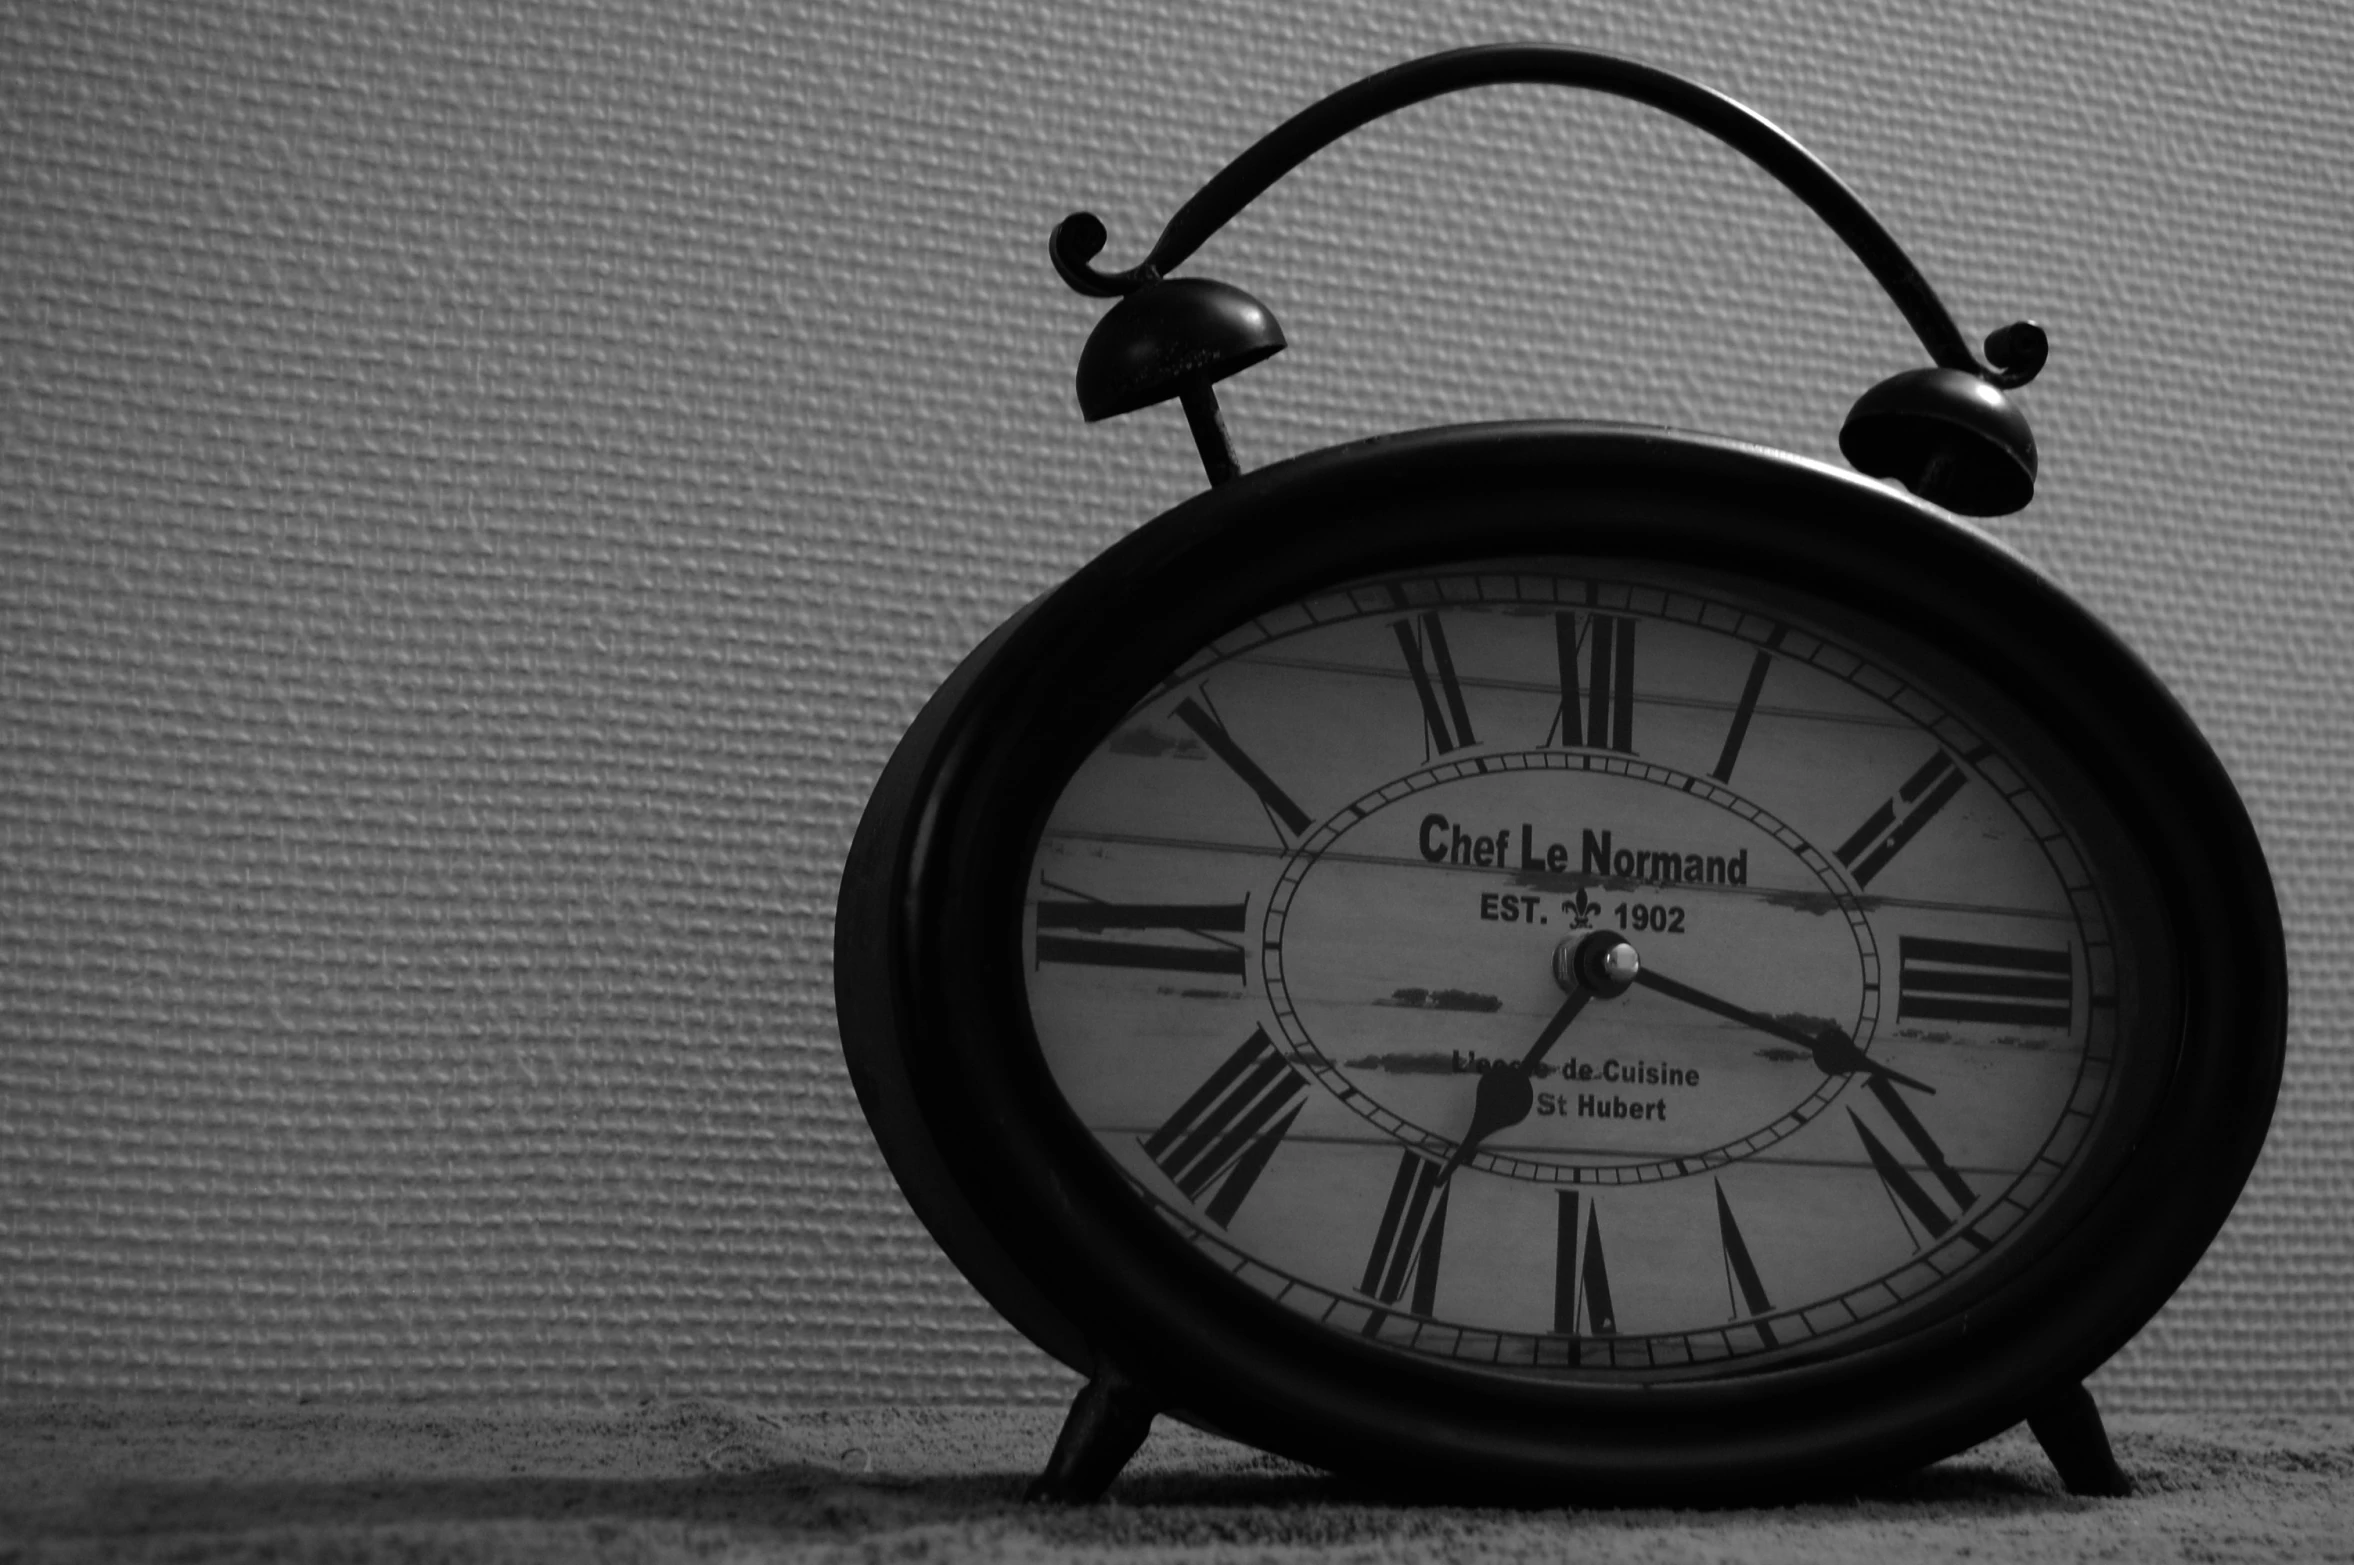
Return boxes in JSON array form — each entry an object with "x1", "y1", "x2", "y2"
[{"x1": 0, "y1": 1400, "x2": 2354, "y2": 1565}]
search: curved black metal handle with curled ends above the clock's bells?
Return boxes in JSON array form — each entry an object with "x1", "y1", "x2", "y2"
[{"x1": 1048, "y1": 45, "x2": 2048, "y2": 388}]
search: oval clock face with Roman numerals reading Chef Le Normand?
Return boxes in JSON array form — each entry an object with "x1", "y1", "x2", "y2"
[{"x1": 1024, "y1": 560, "x2": 2175, "y2": 1379}]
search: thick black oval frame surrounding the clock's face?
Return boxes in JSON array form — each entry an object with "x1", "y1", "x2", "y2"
[{"x1": 836, "y1": 424, "x2": 2286, "y2": 1504}]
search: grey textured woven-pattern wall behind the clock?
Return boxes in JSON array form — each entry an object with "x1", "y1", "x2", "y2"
[{"x1": 0, "y1": 0, "x2": 2354, "y2": 1407}]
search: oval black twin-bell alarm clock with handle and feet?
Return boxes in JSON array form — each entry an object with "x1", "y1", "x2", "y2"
[{"x1": 836, "y1": 47, "x2": 2286, "y2": 1501}]
